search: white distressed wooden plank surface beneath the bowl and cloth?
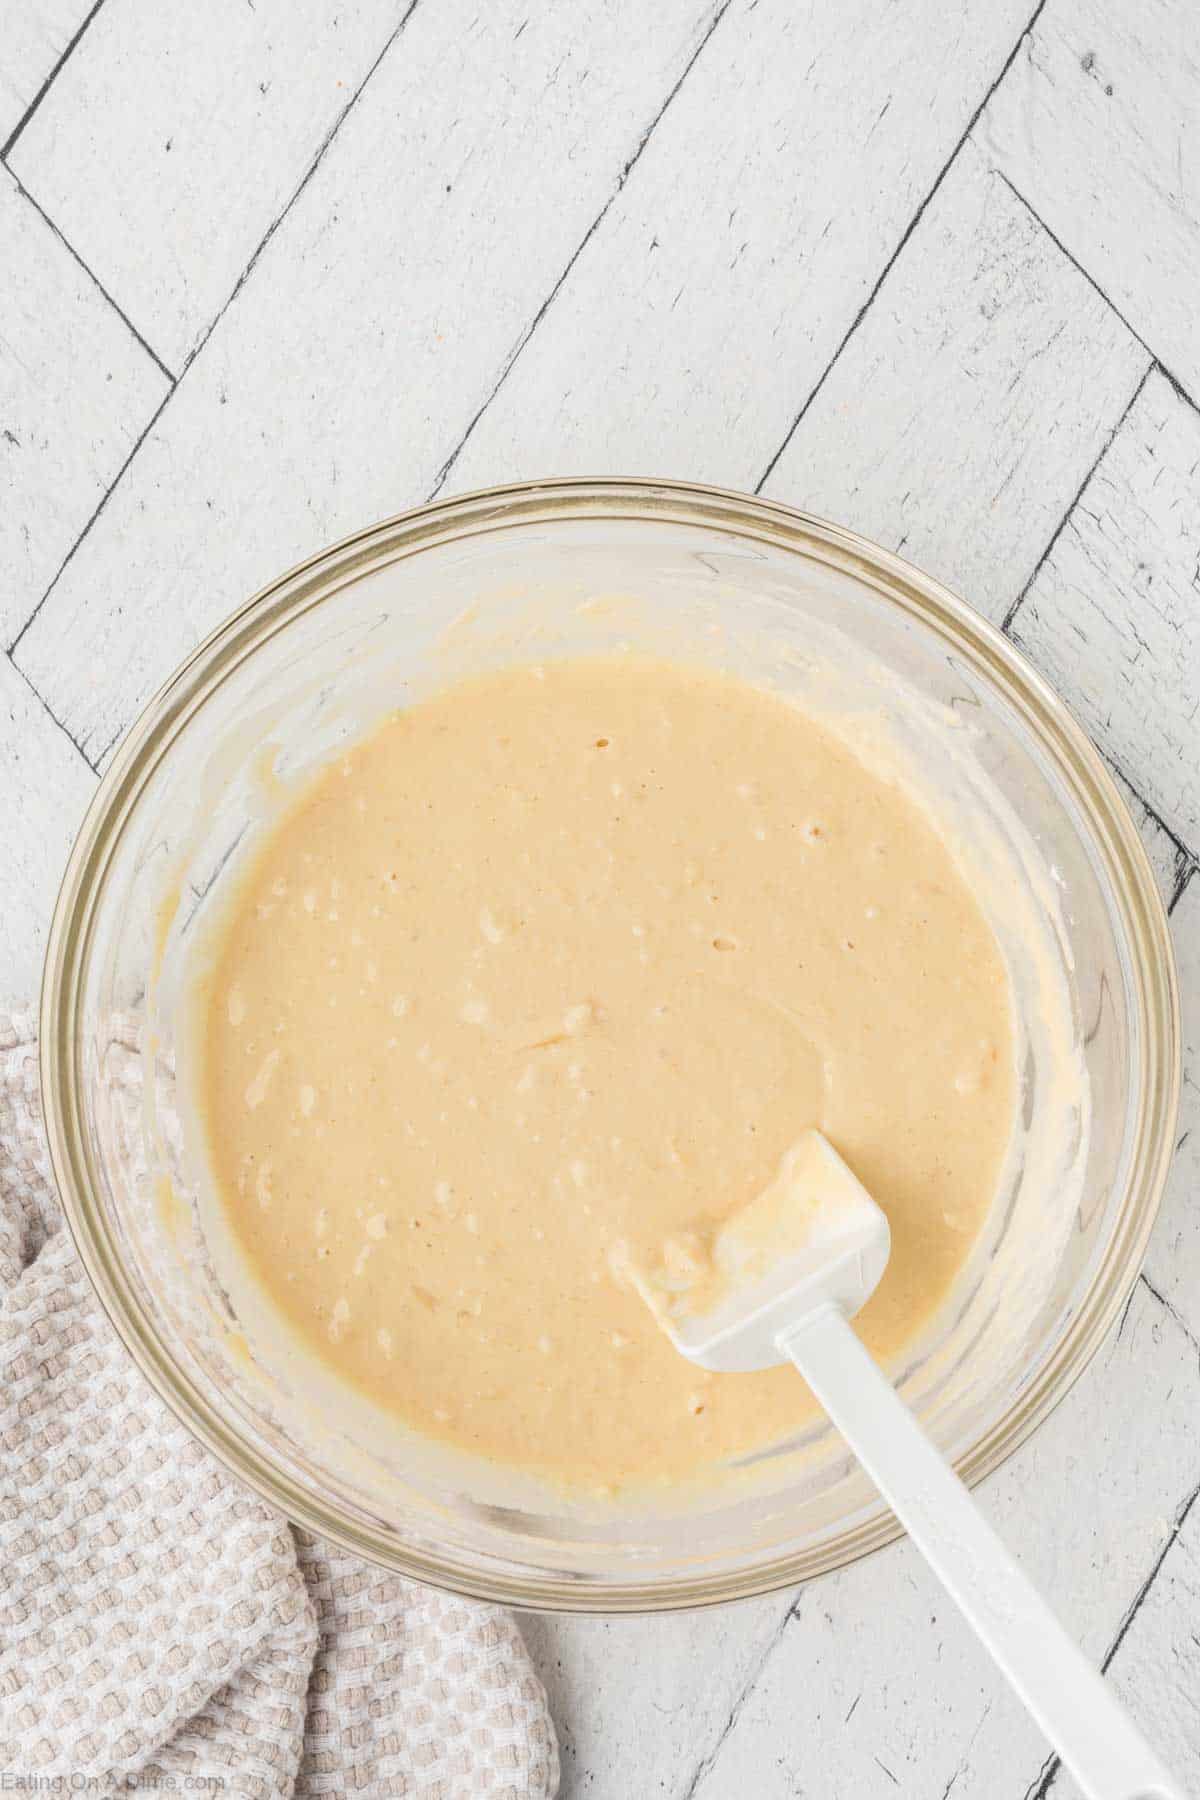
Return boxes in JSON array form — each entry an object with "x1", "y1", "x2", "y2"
[{"x1": 0, "y1": 0, "x2": 1200, "y2": 1800}]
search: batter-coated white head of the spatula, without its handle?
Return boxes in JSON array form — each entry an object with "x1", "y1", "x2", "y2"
[{"x1": 628, "y1": 1130, "x2": 891, "y2": 1370}]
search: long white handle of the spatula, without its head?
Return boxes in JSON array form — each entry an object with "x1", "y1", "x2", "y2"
[{"x1": 777, "y1": 1303, "x2": 1186, "y2": 1800}]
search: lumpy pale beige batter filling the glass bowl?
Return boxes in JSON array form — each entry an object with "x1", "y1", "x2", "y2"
[{"x1": 203, "y1": 659, "x2": 1015, "y2": 1487}]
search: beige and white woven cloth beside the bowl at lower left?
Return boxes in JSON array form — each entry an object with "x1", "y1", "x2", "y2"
[{"x1": 0, "y1": 1013, "x2": 558, "y2": 1800}]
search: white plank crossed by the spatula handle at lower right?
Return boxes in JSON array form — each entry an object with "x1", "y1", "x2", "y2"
[{"x1": 683, "y1": 1283, "x2": 1200, "y2": 1800}]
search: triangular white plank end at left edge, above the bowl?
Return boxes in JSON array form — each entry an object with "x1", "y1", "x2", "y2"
[{"x1": 0, "y1": 169, "x2": 167, "y2": 644}]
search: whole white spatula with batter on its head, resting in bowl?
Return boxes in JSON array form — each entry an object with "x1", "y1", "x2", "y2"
[{"x1": 630, "y1": 1130, "x2": 1184, "y2": 1800}]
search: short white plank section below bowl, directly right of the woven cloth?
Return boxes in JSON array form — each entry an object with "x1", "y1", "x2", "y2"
[{"x1": 522, "y1": 1595, "x2": 795, "y2": 1800}]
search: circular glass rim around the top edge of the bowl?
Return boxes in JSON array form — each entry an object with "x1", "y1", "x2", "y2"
[{"x1": 40, "y1": 477, "x2": 1180, "y2": 1615}]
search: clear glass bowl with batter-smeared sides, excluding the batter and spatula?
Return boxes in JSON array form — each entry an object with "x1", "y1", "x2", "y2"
[{"x1": 41, "y1": 481, "x2": 1178, "y2": 1611}]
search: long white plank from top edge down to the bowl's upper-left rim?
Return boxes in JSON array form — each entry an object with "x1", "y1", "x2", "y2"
[{"x1": 14, "y1": 0, "x2": 726, "y2": 756}]
